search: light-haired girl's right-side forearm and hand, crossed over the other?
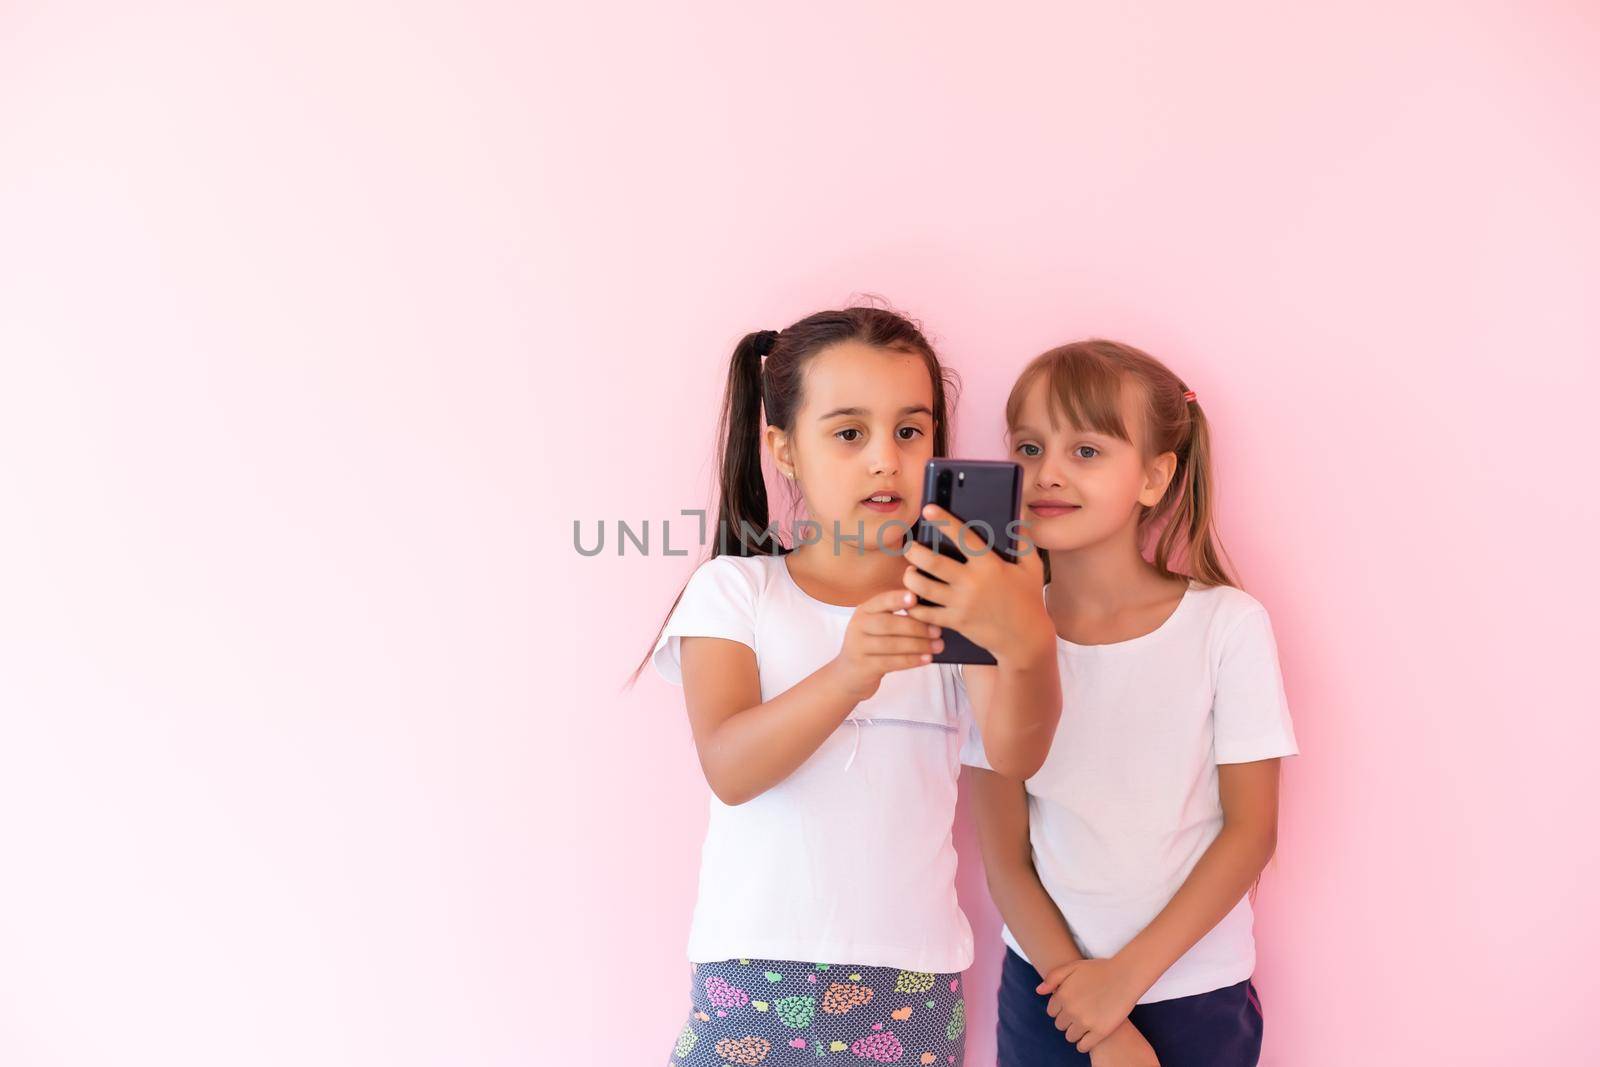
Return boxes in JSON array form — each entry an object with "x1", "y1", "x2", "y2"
[{"x1": 1040, "y1": 758, "x2": 1278, "y2": 1053}]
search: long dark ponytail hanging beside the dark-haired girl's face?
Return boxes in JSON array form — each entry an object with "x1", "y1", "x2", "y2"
[{"x1": 716, "y1": 330, "x2": 782, "y2": 556}]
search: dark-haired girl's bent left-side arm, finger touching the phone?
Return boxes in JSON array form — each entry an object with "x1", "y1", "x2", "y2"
[{"x1": 678, "y1": 590, "x2": 938, "y2": 805}]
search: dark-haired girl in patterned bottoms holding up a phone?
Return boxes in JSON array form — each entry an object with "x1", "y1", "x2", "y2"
[{"x1": 636, "y1": 307, "x2": 1061, "y2": 1067}]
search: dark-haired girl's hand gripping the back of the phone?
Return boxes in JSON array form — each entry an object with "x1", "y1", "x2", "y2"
[{"x1": 906, "y1": 504, "x2": 1056, "y2": 662}]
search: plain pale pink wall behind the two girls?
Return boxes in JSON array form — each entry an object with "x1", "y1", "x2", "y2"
[{"x1": 0, "y1": 0, "x2": 1600, "y2": 1067}]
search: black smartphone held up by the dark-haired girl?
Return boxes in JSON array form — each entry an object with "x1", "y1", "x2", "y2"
[{"x1": 912, "y1": 459, "x2": 1022, "y2": 664}]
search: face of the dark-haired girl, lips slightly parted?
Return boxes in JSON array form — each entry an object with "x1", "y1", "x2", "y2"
[{"x1": 766, "y1": 341, "x2": 934, "y2": 550}]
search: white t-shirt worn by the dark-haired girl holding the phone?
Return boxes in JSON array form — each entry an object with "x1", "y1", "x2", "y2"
[{"x1": 653, "y1": 557, "x2": 973, "y2": 973}]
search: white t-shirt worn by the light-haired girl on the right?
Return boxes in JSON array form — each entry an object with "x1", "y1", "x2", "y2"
[{"x1": 962, "y1": 584, "x2": 1299, "y2": 1003}]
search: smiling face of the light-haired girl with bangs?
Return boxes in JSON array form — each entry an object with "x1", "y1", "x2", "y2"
[{"x1": 1008, "y1": 379, "x2": 1178, "y2": 552}]
